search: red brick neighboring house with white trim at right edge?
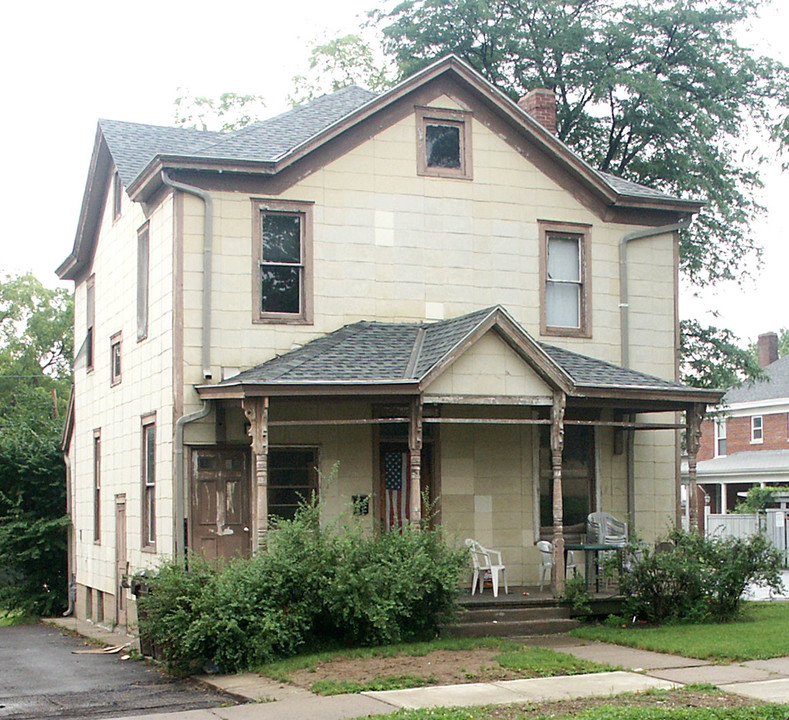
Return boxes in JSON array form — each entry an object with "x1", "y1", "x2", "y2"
[{"x1": 697, "y1": 332, "x2": 789, "y2": 513}]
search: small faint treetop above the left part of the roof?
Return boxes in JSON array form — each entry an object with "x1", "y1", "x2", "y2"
[{"x1": 173, "y1": 88, "x2": 265, "y2": 132}]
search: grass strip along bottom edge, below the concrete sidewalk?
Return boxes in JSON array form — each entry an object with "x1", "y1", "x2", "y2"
[{"x1": 362, "y1": 685, "x2": 789, "y2": 720}]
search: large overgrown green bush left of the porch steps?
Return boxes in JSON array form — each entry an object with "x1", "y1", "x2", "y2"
[{"x1": 139, "y1": 503, "x2": 468, "y2": 671}]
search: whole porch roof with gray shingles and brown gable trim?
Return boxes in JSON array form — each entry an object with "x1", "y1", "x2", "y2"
[{"x1": 197, "y1": 305, "x2": 722, "y2": 409}]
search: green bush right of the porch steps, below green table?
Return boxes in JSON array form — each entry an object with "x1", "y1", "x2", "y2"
[{"x1": 620, "y1": 529, "x2": 781, "y2": 623}]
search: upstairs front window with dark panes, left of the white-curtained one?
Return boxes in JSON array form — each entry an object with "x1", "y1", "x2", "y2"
[{"x1": 253, "y1": 195, "x2": 312, "y2": 323}]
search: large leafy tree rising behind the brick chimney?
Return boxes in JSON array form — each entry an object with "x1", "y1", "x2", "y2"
[{"x1": 374, "y1": 0, "x2": 789, "y2": 285}]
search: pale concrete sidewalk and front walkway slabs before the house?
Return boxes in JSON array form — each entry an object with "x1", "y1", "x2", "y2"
[{"x1": 50, "y1": 618, "x2": 789, "y2": 720}]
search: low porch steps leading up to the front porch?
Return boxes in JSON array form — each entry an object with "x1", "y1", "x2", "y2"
[{"x1": 441, "y1": 601, "x2": 580, "y2": 637}]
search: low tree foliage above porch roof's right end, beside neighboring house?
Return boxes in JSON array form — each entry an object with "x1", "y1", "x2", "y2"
[{"x1": 680, "y1": 320, "x2": 765, "y2": 389}]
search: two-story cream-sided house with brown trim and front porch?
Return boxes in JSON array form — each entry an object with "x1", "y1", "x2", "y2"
[{"x1": 58, "y1": 57, "x2": 720, "y2": 624}]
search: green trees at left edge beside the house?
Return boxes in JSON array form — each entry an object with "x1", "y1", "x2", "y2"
[{"x1": 0, "y1": 274, "x2": 73, "y2": 614}]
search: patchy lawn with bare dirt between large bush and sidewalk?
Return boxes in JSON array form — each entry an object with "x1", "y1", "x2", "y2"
[{"x1": 255, "y1": 638, "x2": 614, "y2": 695}]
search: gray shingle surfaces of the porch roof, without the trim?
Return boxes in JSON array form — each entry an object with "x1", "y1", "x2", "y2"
[{"x1": 221, "y1": 307, "x2": 685, "y2": 390}]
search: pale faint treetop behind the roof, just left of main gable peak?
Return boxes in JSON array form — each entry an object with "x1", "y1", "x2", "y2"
[{"x1": 288, "y1": 35, "x2": 392, "y2": 105}]
